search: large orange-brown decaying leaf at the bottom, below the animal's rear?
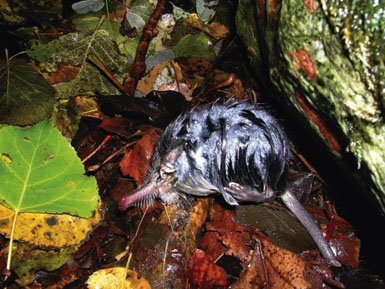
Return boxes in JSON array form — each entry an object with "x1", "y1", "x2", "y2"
[{"x1": 200, "y1": 204, "x2": 328, "y2": 289}]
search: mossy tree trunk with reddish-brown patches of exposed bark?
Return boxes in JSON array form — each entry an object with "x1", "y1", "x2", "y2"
[{"x1": 236, "y1": 0, "x2": 385, "y2": 216}]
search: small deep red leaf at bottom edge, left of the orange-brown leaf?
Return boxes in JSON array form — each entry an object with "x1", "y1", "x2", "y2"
[{"x1": 189, "y1": 249, "x2": 226, "y2": 288}]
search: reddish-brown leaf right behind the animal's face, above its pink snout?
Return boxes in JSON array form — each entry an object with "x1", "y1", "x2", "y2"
[{"x1": 119, "y1": 128, "x2": 159, "y2": 186}]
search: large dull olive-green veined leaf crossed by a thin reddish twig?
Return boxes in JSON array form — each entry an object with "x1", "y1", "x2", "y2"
[{"x1": 40, "y1": 31, "x2": 128, "y2": 99}]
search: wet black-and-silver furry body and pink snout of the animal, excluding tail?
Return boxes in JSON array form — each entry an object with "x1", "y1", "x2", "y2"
[{"x1": 120, "y1": 100, "x2": 290, "y2": 209}]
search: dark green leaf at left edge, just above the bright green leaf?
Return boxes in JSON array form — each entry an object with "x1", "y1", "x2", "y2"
[{"x1": 0, "y1": 58, "x2": 55, "y2": 125}]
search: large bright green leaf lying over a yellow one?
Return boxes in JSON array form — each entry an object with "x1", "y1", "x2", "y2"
[{"x1": 0, "y1": 121, "x2": 99, "y2": 217}]
